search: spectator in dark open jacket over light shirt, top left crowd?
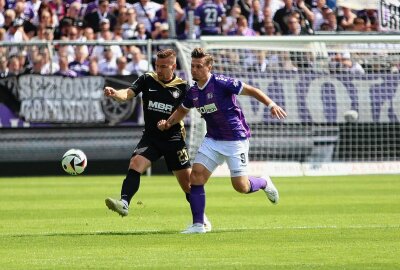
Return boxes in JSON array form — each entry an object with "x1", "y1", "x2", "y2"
[{"x1": 85, "y1": 0, "x2": 117, "y2": 33}]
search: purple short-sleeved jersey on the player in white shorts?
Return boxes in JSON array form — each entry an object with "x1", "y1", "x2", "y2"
[{"x1": 182, "y1": 74, "x2": 250, "y2": 141}]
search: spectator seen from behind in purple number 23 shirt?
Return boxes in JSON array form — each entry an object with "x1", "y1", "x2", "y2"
[{"x1": 194, "y1": 0, "x2": 225, "y2": 36}]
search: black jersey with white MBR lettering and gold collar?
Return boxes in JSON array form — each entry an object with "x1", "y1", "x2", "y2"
[{"x1": 130, "y1": 72, "x2": 189, "y2": 140}]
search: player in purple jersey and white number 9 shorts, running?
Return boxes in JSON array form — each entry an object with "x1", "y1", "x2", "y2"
[{"x1": 157, "y1": 48, "x2": 286, "y2": 233}]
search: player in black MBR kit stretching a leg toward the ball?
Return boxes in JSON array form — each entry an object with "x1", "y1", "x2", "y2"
[{"x1": 104, "y1": 49, "x2": 211, "y2": 230}]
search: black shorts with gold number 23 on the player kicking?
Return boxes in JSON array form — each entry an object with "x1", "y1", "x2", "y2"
[{"x1": 132, "y1": 135, "x2": 191, "y2": 171}]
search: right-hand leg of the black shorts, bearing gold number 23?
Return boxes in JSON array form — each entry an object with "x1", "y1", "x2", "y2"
[{"x1": 158, "y1": 139, "x2": 191, "y2": 171}]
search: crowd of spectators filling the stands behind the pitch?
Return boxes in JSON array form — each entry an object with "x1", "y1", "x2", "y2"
[{"x1": 0, "y1": 0, "x2": 379, "y2": 77}]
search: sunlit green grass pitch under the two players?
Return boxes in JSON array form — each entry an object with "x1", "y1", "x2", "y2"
[{"x1": 0, "y1": 175, "x2": 400, "y2": 270}]
